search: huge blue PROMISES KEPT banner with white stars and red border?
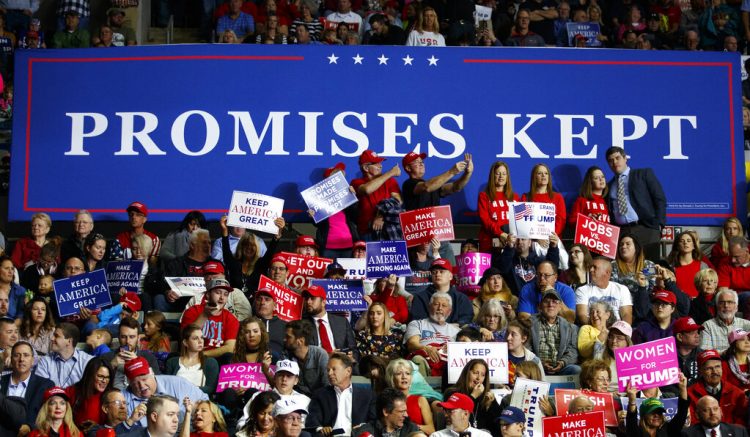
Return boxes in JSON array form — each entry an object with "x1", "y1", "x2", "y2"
[{"x1": 9, "y1": 44, "x2": 745, "y2": 225}]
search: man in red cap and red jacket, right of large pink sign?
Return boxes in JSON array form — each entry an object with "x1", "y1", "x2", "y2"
[{"x1": 688, "y1": 349, "x2": 747, "y2": 426}]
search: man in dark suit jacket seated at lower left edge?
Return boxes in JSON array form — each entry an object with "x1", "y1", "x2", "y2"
[{"x1": 0, "y1": 340, "x2": 55, "y2": 432}]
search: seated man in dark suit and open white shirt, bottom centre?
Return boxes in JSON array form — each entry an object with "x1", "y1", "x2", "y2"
[{"x1": 305, "y1": 352, "x2": 376, "y2": 437}]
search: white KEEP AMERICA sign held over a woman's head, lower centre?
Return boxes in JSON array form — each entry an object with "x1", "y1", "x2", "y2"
[{"x1": 448, "y1": 341, "x2": 508, "y2": 384}]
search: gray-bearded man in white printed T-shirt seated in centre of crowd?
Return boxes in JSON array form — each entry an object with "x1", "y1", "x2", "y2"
[{"x1": 404, "y1": 291, "x2": 460, "y2": 376}]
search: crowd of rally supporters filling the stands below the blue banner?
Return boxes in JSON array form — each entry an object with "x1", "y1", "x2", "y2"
[{"x1": 0, "y1": 147, "x2": 750, "y2": 437}]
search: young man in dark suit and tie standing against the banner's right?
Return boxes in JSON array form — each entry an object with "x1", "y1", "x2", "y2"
[{"x1": 606, "y1": 147, "x2": 667, "y2": 259}]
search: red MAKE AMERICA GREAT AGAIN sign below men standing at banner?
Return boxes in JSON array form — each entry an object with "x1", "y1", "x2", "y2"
[{"x1": 399, "y1": 205, "x2": 456, "y2": 247}]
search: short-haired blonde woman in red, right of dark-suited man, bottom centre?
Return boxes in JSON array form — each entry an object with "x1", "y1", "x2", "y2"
[{"x1": 385, "y1": 358, "x2": 435, "y2": 435}]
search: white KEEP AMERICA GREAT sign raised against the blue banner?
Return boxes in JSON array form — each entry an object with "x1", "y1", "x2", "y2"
[{"x1": 227, "y1": 191, "x2": 284, "y2": 234}]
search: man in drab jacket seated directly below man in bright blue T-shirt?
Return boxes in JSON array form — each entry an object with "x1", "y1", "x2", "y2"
[{"x1": 531, "y1": 287, "x2": 581, "y2": 375}]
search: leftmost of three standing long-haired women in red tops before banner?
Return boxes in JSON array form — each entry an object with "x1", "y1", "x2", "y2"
[{"x1": 477, "y1": 161, "x2": 518, "y2": 253}]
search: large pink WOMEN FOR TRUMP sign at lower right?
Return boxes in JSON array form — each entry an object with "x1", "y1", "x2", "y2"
[{"x1": 615, "y1": 337, "x2": 680, "y2": 392}]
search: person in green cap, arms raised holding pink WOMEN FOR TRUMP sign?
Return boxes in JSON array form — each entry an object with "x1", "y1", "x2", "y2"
[{"x1": 625, "y1": 372, "x2": 690, "y2": 437}]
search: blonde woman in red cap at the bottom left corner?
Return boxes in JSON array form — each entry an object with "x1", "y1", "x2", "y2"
[{"x1": 29, "y1": 387, "x2": 82, "y2": 437}]
